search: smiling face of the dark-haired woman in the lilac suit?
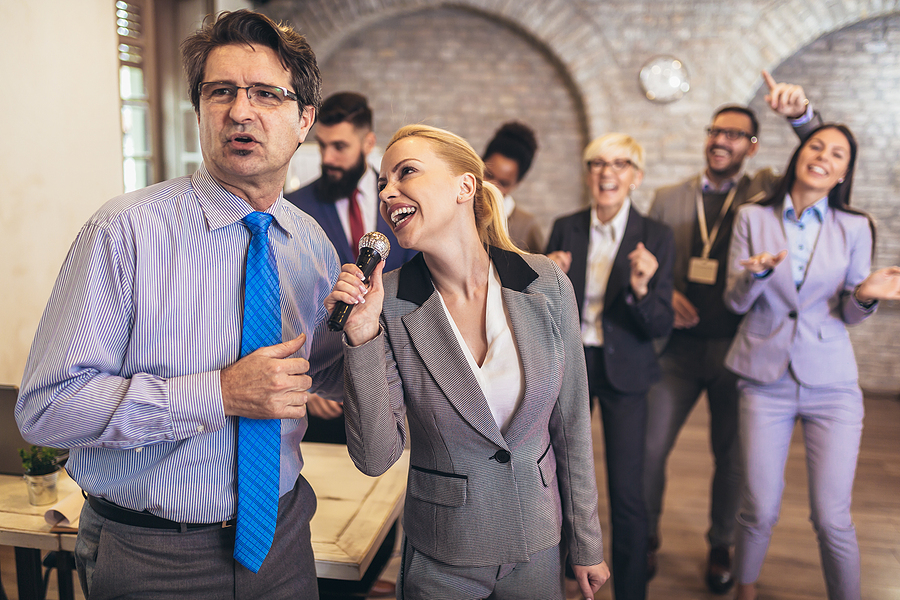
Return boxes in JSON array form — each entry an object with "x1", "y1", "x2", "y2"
[{"x1": 792, "y1": 128, "x2": 850, "y2": 196}]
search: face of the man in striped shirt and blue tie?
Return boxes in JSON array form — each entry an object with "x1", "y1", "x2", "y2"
[{"x1": 197, "y1": 44, "x2": 315, "y2": 210}]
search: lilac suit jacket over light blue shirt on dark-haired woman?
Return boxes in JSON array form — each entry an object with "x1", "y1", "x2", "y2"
[{"x1": 725, "y1": 203, "x2": 875, "y2": 386}]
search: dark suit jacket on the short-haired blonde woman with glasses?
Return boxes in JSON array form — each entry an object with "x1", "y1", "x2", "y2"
[{"x1": 547, "y1": 205, "x2": 675, "y2": 394}]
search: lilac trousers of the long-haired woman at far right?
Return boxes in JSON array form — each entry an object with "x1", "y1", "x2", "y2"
[{"x1": 735, "y1": 370, "x2": 864, "y2": 600}]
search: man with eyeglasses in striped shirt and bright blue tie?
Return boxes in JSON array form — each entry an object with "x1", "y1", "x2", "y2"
[{"x1": 16, "y1": 10, "x2": 342, "y2": 600}]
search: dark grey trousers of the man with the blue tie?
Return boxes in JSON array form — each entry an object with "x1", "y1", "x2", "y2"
[{"x1": 75, "y1": 475, "x2": 319, "y2": 600}]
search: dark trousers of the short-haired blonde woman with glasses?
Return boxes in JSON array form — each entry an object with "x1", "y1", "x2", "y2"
[{"x1": 584, "y1": 347, "x2": 648, "y2": 600}]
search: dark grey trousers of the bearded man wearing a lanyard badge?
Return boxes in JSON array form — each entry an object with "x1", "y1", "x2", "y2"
[{"x1": 644, "y1": 331, "x2": 741, "y2": 547}]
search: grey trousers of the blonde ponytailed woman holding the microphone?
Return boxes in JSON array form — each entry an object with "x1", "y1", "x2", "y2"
[{"x1": 397, "y1": 538, "x2": 565, "y2": 600}]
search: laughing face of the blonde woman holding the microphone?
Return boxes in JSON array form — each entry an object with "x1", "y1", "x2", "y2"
[{"x1": 378, "y1": 136, "x2": 474, "y2": 250}]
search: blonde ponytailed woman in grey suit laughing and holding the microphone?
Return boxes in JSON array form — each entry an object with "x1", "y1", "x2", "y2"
[{"x1": 326, "y1": 125, "x2": 609, "y2": 600}]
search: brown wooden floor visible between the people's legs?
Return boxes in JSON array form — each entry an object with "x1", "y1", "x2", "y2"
[{"x1": 0, "y1": 397, "x2": 900, "y2": 600}]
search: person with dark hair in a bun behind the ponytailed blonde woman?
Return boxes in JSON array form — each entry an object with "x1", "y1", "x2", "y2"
[{"x1": 484, "y1": 121, "x2": 544, "y2": 254}]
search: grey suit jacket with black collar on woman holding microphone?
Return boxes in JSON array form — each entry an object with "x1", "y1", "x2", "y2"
[{"x1": 344, "y1": 248, "x2": 603, "y2": 566}]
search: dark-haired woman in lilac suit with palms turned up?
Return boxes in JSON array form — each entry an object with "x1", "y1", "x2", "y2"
[{"x1": 725, "y1": 124, "x2": 900, "y2": 600}]
